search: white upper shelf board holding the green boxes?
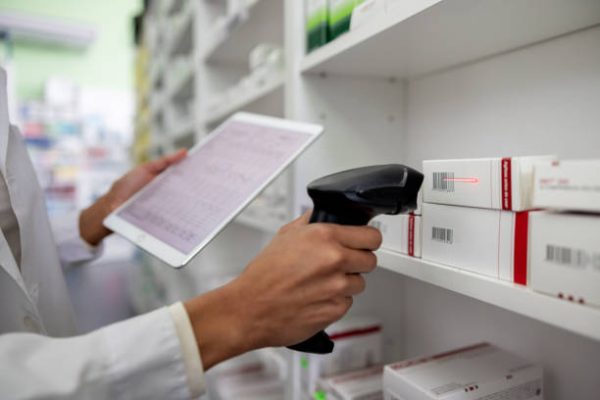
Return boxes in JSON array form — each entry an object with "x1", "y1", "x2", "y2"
[{"x1": 301, "y1": 0, "x2": 600, "y2": 78}]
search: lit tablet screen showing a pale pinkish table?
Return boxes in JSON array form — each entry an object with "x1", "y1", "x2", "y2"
[{"x1": 118, "y1": 119, "x2": 312, "y2": 253}]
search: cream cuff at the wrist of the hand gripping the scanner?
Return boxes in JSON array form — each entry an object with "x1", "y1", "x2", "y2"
[{"x1": 169, "y1": 302, "x2": 204, "y2": 398}]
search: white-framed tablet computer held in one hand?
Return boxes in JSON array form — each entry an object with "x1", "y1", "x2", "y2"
[{"x1": 104, "y1": 113, "x2": 323, "y2": 268}]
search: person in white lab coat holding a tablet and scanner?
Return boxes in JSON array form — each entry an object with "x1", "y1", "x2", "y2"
[{"x1": 0, "y1": 69, "x2": 381, "y2": 400}]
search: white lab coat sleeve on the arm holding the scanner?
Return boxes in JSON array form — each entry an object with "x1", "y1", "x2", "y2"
[{"x1": 0, "y1": 308, "x2": 203, "y2": 400}]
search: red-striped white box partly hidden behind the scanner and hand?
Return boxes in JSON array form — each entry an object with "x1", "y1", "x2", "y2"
[{"x1": 370, "y1": 214, "x2": 421, "y2": 258}]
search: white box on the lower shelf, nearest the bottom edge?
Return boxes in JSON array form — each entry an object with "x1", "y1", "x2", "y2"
[{"x1": 383, "y1": 343, "x2": 543, "y2": 400}]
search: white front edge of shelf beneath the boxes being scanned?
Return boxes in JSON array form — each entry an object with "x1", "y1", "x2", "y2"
[{"x1": 377, "y1": 250, "x2": 600, "y2": 340}]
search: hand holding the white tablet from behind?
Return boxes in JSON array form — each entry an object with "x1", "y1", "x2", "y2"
[{"x1": 79, "y1": 149, "x2": 187, "y2": 246}]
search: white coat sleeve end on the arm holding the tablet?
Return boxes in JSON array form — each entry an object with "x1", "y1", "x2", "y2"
[{"x1": 51, "y1": 211, "x2": 104, "y2": 267}]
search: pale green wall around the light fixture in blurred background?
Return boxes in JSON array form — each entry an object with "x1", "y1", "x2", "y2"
[{"x1": 0, "y1": 0, "x2": 141, "y2": 100}]
